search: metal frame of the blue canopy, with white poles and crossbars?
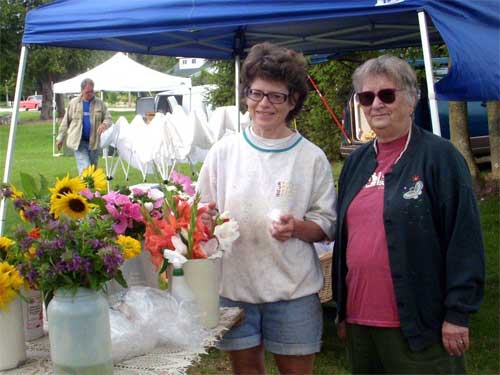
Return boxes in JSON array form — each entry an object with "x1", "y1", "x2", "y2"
[{"x1": 0, "y1": 10, "x2": 441, "y2": 236}]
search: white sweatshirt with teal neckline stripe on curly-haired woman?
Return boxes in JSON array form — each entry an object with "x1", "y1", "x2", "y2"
[{"x1": 197, "y1": 129, "x2": 336, "y2": 303}]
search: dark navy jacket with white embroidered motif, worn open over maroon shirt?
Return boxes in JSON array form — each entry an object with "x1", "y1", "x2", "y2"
[{"x1": 332, "y1": 126, "x2": 484, "y2": 351}]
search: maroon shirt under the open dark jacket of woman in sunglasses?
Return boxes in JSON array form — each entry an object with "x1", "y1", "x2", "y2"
[{"x1": 346, "y1": 134, "x2": 408, "y2": 327}]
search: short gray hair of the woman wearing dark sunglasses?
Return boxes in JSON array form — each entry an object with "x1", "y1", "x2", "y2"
[{"x1": 352, "y1": 55, "x2": 419, "y2": 108}]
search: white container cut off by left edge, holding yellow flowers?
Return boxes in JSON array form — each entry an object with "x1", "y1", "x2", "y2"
[{"x1": 0, "y1": 297, "x2": 26, "y2": 370}]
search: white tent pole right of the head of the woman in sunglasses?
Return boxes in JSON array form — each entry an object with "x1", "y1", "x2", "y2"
[{"x1": 418, "y1": 10, "x2": 441, "y2": 136}]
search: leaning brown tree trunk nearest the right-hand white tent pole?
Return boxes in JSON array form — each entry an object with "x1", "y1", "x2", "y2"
[{"x1": 448, "y1": 101, "x2": 481, "y2": 188}]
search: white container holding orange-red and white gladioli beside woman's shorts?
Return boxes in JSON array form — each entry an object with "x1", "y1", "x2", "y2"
[{"x1": 182, "y1": 259, "x2": 220, "y2": 328}]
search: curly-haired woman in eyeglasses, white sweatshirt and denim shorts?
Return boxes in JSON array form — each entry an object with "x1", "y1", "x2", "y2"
[{"x1": 198, "y1": 43, "x2": 335, "y2": 374}]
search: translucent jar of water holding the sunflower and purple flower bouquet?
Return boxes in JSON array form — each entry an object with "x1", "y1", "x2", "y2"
[{"x1": 47, "y1": 288, "x2": 113, "y2": 375}]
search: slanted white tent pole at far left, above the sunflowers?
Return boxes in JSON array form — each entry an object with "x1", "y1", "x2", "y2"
[{"x1": 0, "y1": 45, "x2": 28, "y2": 236}]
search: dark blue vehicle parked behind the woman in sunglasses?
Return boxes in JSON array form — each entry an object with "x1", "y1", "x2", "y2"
[{"x1": 340, "y1": 93, "x2": 490, "y2": 161}]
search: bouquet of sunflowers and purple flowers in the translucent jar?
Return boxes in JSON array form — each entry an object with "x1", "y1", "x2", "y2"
[{"x1": 0, "y1": 166, "x2": 141, "y2": 295}]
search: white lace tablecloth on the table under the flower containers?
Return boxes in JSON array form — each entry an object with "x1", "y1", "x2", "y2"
[{"x1": 0, "y1": 307, "x2": 243, "y2": 375}]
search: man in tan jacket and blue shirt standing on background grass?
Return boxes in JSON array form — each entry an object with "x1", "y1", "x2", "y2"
[{"x1": 57, "y1": 78, "x2": 112, "y2": 174}]
